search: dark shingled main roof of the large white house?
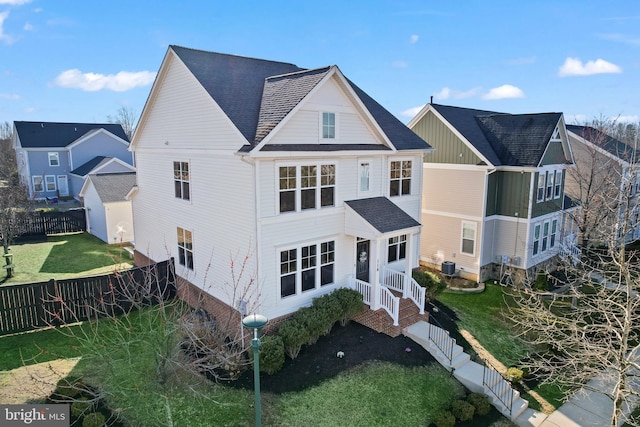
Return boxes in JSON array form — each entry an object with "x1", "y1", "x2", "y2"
[{"x1": 170, "y1": 45, "x2": 431, "y2": 152}]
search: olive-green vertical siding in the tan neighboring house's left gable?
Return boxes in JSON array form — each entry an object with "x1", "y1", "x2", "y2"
[{"x1": 412, "y1": 111, "x2": 482, "y2": 165}]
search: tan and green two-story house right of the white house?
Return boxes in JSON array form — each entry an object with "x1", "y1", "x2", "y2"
[{"x1": 409, "y1": 104, "x2": 572, "y2": 282}]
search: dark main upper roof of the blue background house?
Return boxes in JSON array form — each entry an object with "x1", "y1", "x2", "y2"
[{"x1": 14, "y1": 122, "x2": 129, "y2": 148}]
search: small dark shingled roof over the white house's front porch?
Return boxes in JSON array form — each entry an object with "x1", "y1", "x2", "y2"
[{"x1": 345, "y1": 197, "x2": 420, "y2": 233}]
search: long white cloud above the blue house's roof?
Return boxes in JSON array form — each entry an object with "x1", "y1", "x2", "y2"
[{"x1": 54, "y1": 68, "x2": 156, "y2": 92}]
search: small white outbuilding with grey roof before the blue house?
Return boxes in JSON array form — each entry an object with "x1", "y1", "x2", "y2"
[{"x1": 79, "y1": 172, "x2": 136, "y2": 244}]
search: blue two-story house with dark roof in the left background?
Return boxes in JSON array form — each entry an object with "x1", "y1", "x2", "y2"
[{"x1": 13, "y1": 121, "x2": 134, "y2": 199}]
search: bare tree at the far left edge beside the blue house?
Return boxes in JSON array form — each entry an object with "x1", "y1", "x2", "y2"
[{"x1": 0, "y1": 129, "x2": 30, "y2": 278}]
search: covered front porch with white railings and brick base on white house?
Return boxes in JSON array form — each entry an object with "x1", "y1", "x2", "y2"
[{"x1": 345, "y1": 197, "x2": 425, "y2": 336}]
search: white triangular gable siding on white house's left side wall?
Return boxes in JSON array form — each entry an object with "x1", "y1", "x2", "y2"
[{"x1": 135, "y1": 53, "x2": 247, "y2": 151}]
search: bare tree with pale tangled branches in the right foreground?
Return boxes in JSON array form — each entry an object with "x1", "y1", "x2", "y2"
[{"x1": 510, "y1": 158, "x2": 640, "y2": 427}]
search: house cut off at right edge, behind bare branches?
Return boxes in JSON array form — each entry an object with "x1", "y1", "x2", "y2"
[{"x1": 566, "y1": 125, "x2": 640, "y2": 246}]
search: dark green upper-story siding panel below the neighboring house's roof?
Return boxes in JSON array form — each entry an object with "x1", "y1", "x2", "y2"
[{"x1": 486, "y1": 171, "x2": 537, "y2": 217}]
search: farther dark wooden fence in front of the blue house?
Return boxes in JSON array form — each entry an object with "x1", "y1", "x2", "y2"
[{"x1": 15, "y1": 209, "x2": 87, "y2": 240}]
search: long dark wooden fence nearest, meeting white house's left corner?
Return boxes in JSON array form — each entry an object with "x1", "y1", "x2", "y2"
[{"x1": 0, "y1": 258, "x2": 176, "y2": 335}]
